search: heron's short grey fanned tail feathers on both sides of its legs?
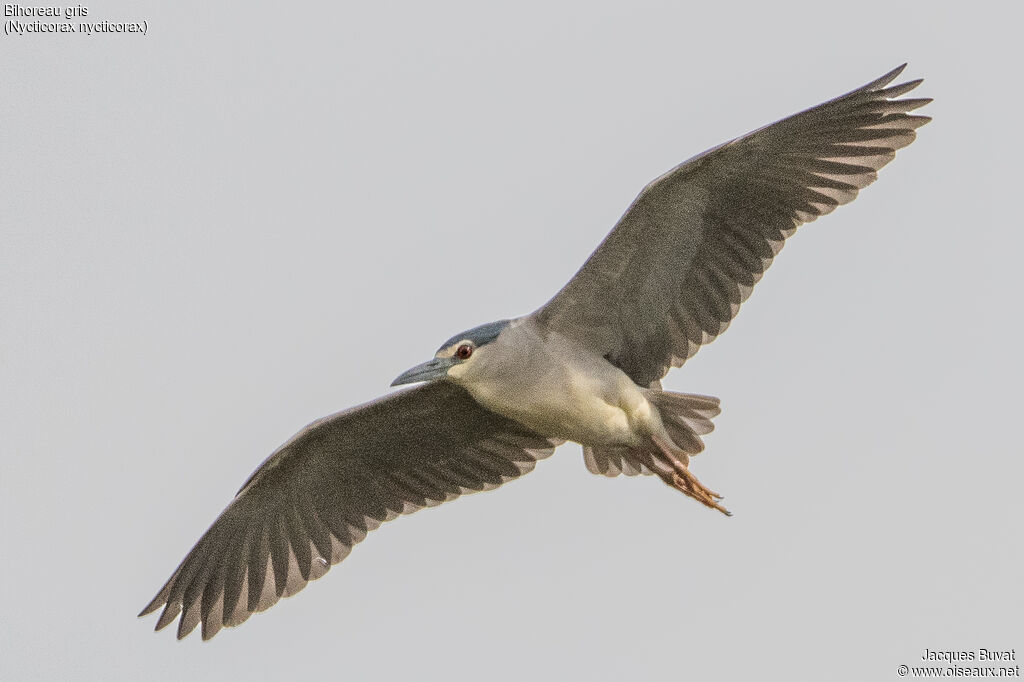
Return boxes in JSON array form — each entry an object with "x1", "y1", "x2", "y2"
[{"x1": 583, "y1": 388, "x2": 722, "y2": 476}]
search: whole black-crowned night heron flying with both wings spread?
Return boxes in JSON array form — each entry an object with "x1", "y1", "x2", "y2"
[{"x1": 140, "y1": 65, "x2": 930, "y2": 639}]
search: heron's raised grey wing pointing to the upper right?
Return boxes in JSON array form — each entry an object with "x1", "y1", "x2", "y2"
[{"x1": 534, "y1": 65, "x2": 931, "y2": 386}]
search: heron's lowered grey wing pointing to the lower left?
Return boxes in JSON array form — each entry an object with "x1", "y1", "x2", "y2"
[{"x1": 139, "y1": 382, "x2": 558, "y2": 639}]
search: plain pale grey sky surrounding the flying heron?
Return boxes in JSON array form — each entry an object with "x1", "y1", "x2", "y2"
[{"x1": 0, "y1": 2, "x2": 1024, "y2": 680}]
